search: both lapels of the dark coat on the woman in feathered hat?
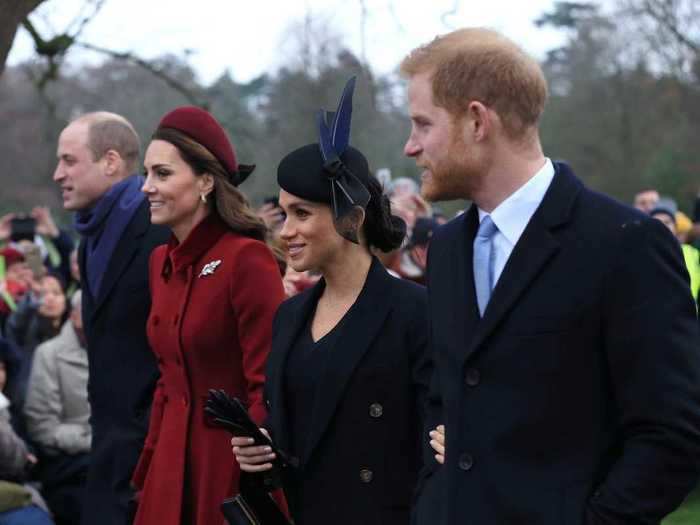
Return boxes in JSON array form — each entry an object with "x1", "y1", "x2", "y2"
[{"x1": 271, "y1": 258, "x2": 395, "y2": 466}]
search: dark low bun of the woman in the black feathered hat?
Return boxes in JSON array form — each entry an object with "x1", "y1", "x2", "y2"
[{"x1": 362, "y1": 176, "x2": 406, "y2": 253}]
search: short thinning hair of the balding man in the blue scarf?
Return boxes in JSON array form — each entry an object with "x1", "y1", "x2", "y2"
[{"x1": 76, "y1": 111, "x2": 141, "y2": 174}]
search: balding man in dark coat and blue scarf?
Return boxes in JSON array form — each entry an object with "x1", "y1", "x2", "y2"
[{"x1": 54, "y1": 112, "x2": 168, "y2": 525}]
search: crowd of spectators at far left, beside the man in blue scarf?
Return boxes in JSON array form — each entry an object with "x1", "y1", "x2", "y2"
[{"x1": 0, "y1": 207, "x2": 82, "y2": 525}]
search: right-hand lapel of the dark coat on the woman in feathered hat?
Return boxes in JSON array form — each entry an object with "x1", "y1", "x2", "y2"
[{"x1": 302, "y1": 258, "x2": 393, "y2": 465}]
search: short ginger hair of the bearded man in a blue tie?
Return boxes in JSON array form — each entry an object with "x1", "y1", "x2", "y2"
[{"x1": 401, "y1": 28, "x2": 547, "y2": 138}]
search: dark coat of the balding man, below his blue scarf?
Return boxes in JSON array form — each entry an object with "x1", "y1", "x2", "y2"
[{"x1": 78, "y1": 200, "x2": 170, "y2": 525}]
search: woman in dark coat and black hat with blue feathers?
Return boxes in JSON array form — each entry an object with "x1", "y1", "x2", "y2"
[{"x1": 232, "y1": 81, "x2": 430, "y2": 525}]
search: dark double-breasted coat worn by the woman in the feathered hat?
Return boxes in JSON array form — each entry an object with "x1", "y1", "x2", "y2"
[{"x1": 265, "y1": 259, "x2": 431, "y2": 525}]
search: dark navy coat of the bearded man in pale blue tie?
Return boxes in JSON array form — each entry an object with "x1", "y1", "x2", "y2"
[{"x1": 416, "y1": 163, "x2": 700, "y2": 525}]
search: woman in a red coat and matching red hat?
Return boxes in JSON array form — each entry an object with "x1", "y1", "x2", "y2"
[{"x1": 133, "y1": 107, "x2": 284, "y2": 525}]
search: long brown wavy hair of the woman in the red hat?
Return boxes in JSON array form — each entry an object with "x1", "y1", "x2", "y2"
[{"x1": 151, "y1": 128, "x2": 267, "y2": 241}]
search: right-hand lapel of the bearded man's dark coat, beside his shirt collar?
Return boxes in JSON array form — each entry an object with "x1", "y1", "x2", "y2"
[{"x1": 463, "y1": 163, "x2": 582, "y2": 361}]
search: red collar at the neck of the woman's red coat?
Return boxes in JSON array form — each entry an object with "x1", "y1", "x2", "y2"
[{"x1": 161, "y1": 213, "x2": 229, "y2": 276}]
